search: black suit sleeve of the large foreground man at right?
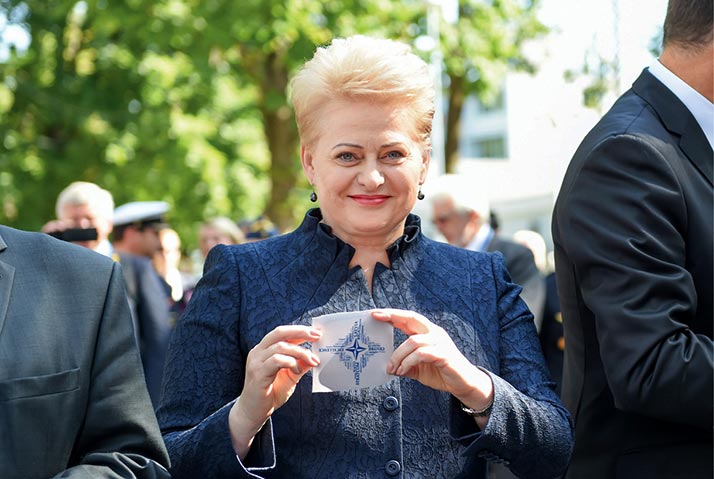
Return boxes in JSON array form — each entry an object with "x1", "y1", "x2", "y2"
[{"x1": 558, "y1": 135, "x2": 714, "y2": 428}]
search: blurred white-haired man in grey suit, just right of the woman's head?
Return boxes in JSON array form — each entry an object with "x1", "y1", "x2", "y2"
[{"x1": 431, "y1": 179, "x2": 545, "y2": 329}]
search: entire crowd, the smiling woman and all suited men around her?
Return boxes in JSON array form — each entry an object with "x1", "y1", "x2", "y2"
[{"x1": 0, "y1": 0, "x2": 714, "y2": 479}]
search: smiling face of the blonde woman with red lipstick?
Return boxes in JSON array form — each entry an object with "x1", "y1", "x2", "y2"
[{"x1": 301, "y1": 100, "x2": 429, "y2": 245}]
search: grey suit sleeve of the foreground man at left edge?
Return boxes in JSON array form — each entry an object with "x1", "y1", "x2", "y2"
[{"x1": 56, "y1": 263, "x2": 169, "y2": 479}]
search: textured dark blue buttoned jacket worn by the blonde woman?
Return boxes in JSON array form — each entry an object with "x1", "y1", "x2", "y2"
[{"x1": 158, "y1": 209, "x2": 573, "y2": 479}]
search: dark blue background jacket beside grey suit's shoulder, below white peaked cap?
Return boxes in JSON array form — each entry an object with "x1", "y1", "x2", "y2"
[{"x1": 119, "y1": 253, "x2": 171, "y2": 408}]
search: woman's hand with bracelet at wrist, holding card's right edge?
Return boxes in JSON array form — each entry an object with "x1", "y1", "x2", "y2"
[{"x1": 372, "y1": 309, "x2": 493, "y2": 416}]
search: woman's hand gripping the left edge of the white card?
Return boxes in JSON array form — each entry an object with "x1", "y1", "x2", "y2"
[{"x1": 228, "y1": 325, "x2": 320, "y2": 460}]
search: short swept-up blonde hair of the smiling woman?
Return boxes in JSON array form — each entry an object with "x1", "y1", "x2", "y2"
[{"x1": 290, "y1": 35, "x2": 435, "y2": 147}]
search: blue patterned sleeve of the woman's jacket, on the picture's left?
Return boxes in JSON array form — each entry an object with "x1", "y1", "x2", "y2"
[{"x1": 157, "y1": 245, "x2": 275, "y2": 479}]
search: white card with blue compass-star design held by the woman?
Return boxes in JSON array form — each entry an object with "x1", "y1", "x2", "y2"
[{"x1": 312, "y1": 311, "x2": 394, "y2": 392}]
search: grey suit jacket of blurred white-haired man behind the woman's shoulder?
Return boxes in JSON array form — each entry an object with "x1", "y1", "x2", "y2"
[{"x1": 486, "y1": 235, "x2": 545, "y2": 330}]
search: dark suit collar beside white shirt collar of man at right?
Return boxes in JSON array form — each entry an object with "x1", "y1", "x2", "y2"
[{"x1": 632, "y1": 70, "x2": 714, "y2": 185}]
